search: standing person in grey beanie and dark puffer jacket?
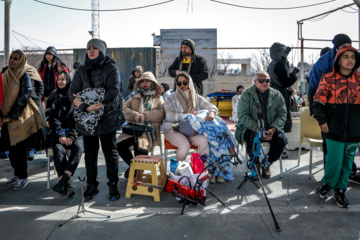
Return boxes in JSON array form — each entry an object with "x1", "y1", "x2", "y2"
[{"x1": 69, "y1": 38, "x2": 121, "y2": 201}]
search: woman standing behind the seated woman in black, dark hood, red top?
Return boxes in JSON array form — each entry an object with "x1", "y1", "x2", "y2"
[{"x1": 38, "y1": 46, "x2": 69, "y2": 97}]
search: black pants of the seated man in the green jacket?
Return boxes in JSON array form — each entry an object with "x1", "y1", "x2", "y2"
[{"x1": 244, "y1": 129, "x2": 286, "y2": 164}]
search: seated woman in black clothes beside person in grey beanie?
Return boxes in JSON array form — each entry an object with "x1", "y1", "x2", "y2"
[{"x1": 48, "y1": 71, "x2": 84, "y2": 197}]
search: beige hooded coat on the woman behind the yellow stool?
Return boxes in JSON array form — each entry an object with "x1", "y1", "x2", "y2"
[{"x1": 116, "y1": 72, "x2": 165, "y2": 152}]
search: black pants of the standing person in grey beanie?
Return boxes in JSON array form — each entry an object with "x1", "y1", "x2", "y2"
[{"x1": 83, "y1": 132, "x2": 119, "y2": 186}]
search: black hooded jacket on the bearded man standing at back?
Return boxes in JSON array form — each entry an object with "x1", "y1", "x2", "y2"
[{"x1": 169, "y1": 39, "x2": 209, "y2": 95}]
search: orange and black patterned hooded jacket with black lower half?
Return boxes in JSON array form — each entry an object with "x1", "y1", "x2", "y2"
[{"x1": 313, "y1": 45, "x2": 360, "y2": 143}]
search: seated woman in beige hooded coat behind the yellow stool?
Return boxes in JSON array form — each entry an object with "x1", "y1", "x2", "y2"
[{"x1": 117, "y1": 72, "x2": 165, "y2": 178}]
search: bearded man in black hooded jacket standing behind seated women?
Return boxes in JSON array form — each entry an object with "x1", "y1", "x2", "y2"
[{"x1": 169, "y1": 39, "x2": 209, "y2": 95}]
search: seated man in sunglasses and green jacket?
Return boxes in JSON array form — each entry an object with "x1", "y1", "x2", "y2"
[{"x1": 235, "y1": 71, "x2": 287, "y2": 178}]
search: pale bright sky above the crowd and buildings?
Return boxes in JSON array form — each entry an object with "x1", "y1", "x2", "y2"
[{"x1": 0, "y1": 0, "x2": 359, "y2": 62}]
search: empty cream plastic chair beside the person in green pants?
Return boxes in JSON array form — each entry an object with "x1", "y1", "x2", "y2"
[{"x1": 298, "y1": 107, "x2": 323, "y2": 179}]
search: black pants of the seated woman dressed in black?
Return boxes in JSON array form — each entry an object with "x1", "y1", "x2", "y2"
[{"x1": 52, "y1": 138, "x2": 84, "y2": 177}]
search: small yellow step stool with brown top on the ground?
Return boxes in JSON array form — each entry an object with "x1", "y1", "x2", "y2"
[{"x1": 125, "y1": 155, "x2": 166, "y2": 202}]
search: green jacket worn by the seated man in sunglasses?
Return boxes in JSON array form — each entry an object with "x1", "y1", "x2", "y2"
[{"x1": 235, "y1": 85, "x2": 287, "y2": 144}]
